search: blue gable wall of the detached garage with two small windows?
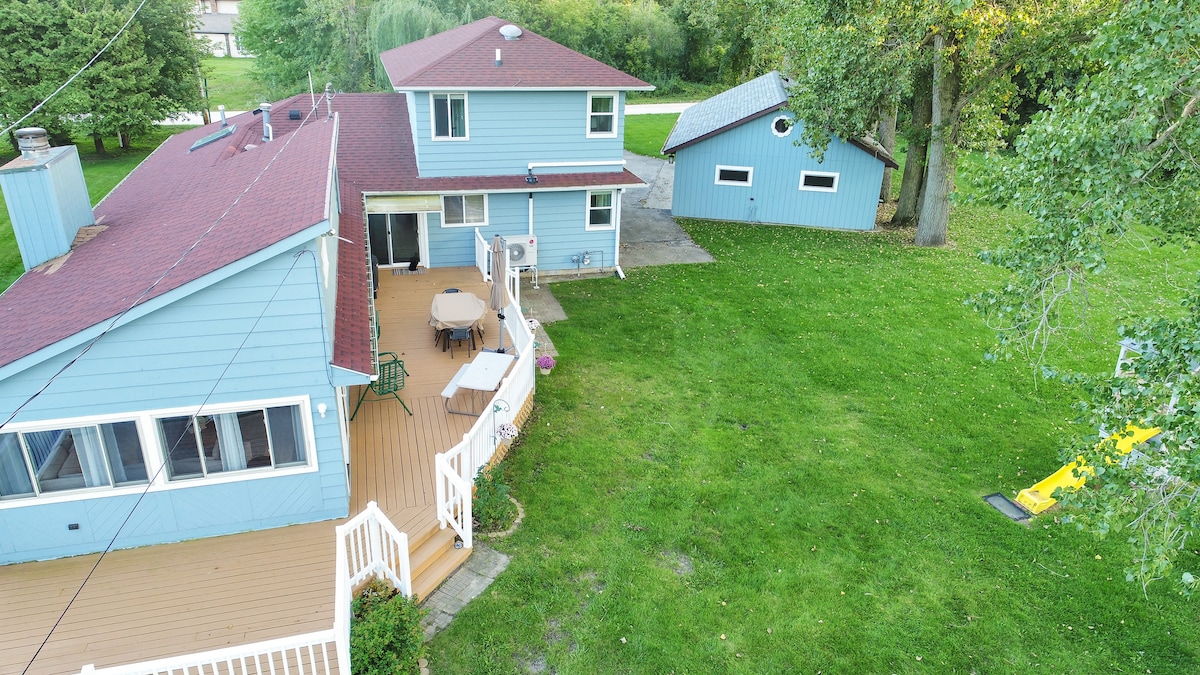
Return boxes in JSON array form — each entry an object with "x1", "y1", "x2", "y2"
[{"x1": 671, "y1": 115, "x2": 883, "y2": 229}]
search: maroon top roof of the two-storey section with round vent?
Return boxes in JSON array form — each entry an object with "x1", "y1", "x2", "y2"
[{"x1": 379, "y1": 17, "x2": 654, "y2": 91}]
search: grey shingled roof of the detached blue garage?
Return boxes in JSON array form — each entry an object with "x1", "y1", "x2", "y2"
[{"x1": 662, "y1": 71, "x2": 900, "y2": 168}]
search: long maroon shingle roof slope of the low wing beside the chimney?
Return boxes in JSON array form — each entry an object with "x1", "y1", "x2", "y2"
[{"x1": 0, "y1": 104, "x2": 335, "y2": 366}]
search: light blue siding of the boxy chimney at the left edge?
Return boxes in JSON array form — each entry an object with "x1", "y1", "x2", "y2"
[{"x1": 0, "y1": 145, "x2": 95, "y2": 270}]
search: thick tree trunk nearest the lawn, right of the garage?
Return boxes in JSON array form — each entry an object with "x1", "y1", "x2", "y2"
[{"x1": 916, "y1": 34, "x2": 960, "y2": 246}]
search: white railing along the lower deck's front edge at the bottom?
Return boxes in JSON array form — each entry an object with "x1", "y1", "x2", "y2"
[{"x1": 79, "y1": 629, "x2": 350, "y2": 675}]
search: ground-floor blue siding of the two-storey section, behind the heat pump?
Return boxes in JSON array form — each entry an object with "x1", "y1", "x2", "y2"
[{"x1": 428, "y1": 190, "x2": 617, "y2": 271}]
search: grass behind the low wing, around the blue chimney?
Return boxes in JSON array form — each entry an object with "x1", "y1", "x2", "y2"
[{"x1": 0, "y1": 125, "x2": 192, "y2": 291}]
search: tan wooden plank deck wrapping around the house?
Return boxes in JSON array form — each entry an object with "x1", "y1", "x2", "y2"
[{"x1": 0, "y1": 268, "x2": 499, "y2": 675}]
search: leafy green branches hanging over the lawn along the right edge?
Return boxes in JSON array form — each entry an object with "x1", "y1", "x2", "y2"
[{"x1": 976, "y1": 0, "x2": 1200, "y2": 592}]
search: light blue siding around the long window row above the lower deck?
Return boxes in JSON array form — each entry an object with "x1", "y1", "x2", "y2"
[{"x1": 0, "y1": 245, "x2": 349, "y2": 563}]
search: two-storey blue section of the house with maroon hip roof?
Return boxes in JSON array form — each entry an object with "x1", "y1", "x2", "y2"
[{"x1": 367, "y1": 17, "x2": 653, "y2": 271}]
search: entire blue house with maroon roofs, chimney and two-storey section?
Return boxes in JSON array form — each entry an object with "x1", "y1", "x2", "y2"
[{"x1": 0, "y1": 17, "x2": 650, "y2": 565}]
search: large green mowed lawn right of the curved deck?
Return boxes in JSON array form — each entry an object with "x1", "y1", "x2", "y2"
[{"x1": 431, "y1": 205, "x2": 1200, "y2": 674}]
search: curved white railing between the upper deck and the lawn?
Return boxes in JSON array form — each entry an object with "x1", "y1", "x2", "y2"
[{"x1": 433, "y1": 301, "x2": 534, "y2": 549}]
